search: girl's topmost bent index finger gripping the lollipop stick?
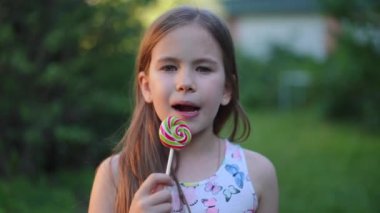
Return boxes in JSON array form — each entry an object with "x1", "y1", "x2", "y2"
[{"x1": 135, "y1": 173, "x2": 173, "y2": 196}]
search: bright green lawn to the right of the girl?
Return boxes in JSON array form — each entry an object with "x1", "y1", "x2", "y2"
[{"x1": 244, "y1": 111, "x2": 380, "y2": 212}]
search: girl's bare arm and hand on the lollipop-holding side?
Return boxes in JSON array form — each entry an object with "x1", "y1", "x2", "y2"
[{"x1": 88, "y1": 155, "x2": 173, "y2": 213}]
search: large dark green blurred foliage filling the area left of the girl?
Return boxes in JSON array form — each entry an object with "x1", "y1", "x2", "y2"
[{"x1": 0, "y1": 0, "x2": 154, "y2": 175}]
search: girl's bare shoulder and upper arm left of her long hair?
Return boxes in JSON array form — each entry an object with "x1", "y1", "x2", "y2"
[{"x1": 89, "y1": 155, "x2": 119, "y2": 213}]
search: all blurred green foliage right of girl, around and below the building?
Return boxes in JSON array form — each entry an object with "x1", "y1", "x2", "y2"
[{"x1": 237, "y1": 0, "x2": 380, "y2": 132}]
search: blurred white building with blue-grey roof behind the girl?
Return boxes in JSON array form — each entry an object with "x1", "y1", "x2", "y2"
[{"x1": 222, "y1": 0, "x2": 339, "y2": 60}]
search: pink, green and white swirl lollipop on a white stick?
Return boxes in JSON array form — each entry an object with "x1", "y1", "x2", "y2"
[{"x1": 159, "y1": 116, "x2": 191, "y2": 174}]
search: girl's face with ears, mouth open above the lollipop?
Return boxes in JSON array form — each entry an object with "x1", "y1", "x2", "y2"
[{"x1": 138, "y1": 24, "x2": 231, "y2": 134}]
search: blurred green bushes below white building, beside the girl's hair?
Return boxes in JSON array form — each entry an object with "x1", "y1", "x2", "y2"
[{"x1": 237, "y1": 46, "x2": 321, "y2": 108}]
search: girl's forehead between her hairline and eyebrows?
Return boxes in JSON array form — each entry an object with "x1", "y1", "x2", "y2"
[{"x1": 152, "y1": 24, "x2": 222, "y2": 63}]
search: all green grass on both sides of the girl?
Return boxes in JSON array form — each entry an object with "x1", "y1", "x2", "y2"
[{"x1": 0, "y1": 111, "x2": 380, "y2": 213}]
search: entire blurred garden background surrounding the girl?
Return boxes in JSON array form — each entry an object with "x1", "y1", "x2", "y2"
[{"x1": 0, "y1": 0, "x2": 380, "y2": 213}]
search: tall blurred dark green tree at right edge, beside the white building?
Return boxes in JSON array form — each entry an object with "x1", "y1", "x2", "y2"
[{"x1": 321, "y1": 0, "x2": 380, "y2": 130}]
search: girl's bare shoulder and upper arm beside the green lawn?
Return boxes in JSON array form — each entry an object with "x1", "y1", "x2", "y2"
[{"x1": 243, "y1": 149, "x2": 278, "y2": 212}]
